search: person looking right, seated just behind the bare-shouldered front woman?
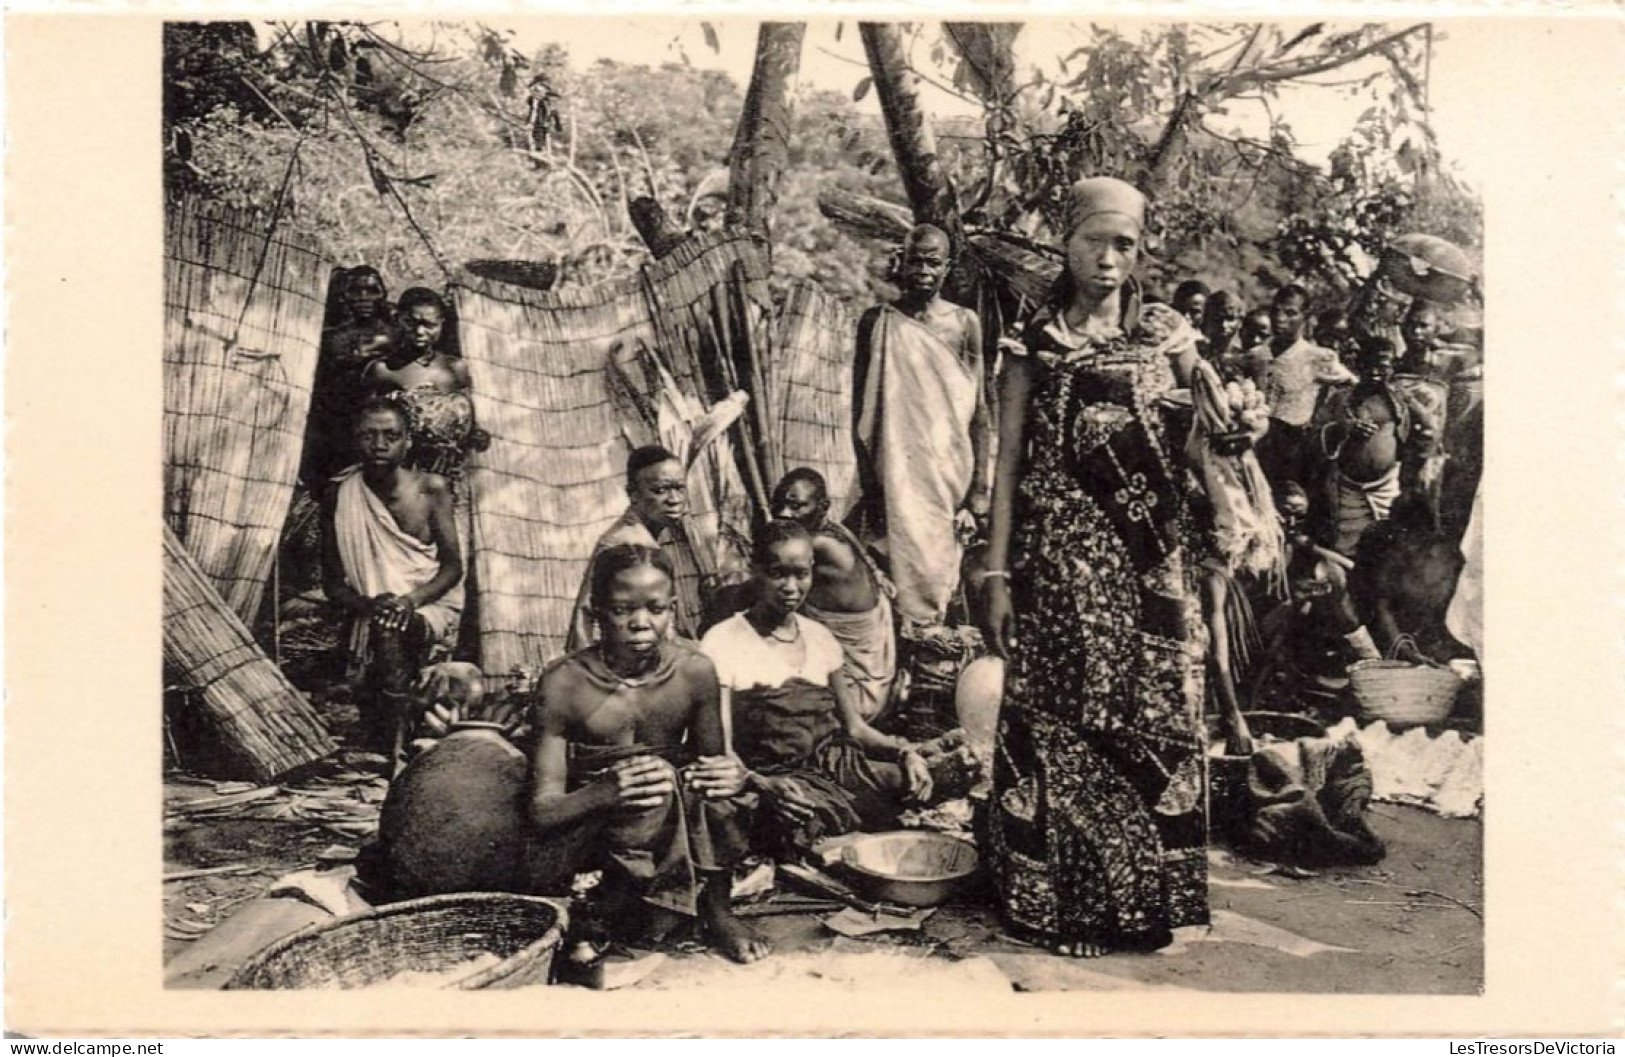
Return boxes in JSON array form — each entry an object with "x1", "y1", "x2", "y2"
[{"x1": 566, "y1": 444, "x2": 707, "y2": 654}]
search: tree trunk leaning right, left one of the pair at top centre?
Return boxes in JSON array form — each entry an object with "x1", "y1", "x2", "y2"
[{"x1": 728, "y1": 23, "x2": 806, "y2": 237}]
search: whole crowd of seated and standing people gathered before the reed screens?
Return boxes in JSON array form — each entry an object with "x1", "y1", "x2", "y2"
[{"x1": 302, "y1": 177, "x2": 1482, "y2": 961}]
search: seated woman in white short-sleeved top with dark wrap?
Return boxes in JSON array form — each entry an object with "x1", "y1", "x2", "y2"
[{"x1": 700, "y1": 520, "x2": 933, "y2": 855}]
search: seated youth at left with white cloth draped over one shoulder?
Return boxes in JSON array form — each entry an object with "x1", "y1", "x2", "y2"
[{"x1": 322, "y1": 402, "x2": 463, "y2": 763}]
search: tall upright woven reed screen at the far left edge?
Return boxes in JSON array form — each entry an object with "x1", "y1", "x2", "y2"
[{"x1": 164, "y1": 200, "x2": 332, "y2": 626}]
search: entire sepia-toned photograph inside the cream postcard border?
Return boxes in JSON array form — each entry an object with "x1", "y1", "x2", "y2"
[{"x1": 153, "y1": 18, "x2": 1493, "y2": 1002}]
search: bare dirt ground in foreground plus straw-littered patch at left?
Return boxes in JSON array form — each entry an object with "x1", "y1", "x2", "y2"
[{"x1": 164, "y1": 756, "x2": 1484, "y2": 994}]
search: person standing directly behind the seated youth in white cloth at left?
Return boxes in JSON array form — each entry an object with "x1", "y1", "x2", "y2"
[{"x1": 362, "y1": 286, "x2": 491, "y2": 481}]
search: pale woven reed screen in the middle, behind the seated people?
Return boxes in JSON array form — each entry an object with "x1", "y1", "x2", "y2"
[{"x1": 457, "y1": 236, "x2": 765, "y2": 672}]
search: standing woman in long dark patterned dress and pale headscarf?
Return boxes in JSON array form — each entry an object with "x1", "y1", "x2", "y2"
[{"x1": 983, "y1": 177, "x2": 1207, "y2": 956}]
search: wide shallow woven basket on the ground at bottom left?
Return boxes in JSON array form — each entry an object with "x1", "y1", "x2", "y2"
[{"x1": 226, "y1": 893, "x2": 566, "y2": 990}]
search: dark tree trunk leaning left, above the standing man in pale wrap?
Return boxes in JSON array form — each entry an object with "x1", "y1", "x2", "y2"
[{"x1": 858, "y1": 23, "x2": 964, "y2": 245}]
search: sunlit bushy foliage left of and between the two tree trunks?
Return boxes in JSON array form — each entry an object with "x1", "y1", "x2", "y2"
[{"x1": 164, "y1": 23, "x2": 894, "y2": 298}]
